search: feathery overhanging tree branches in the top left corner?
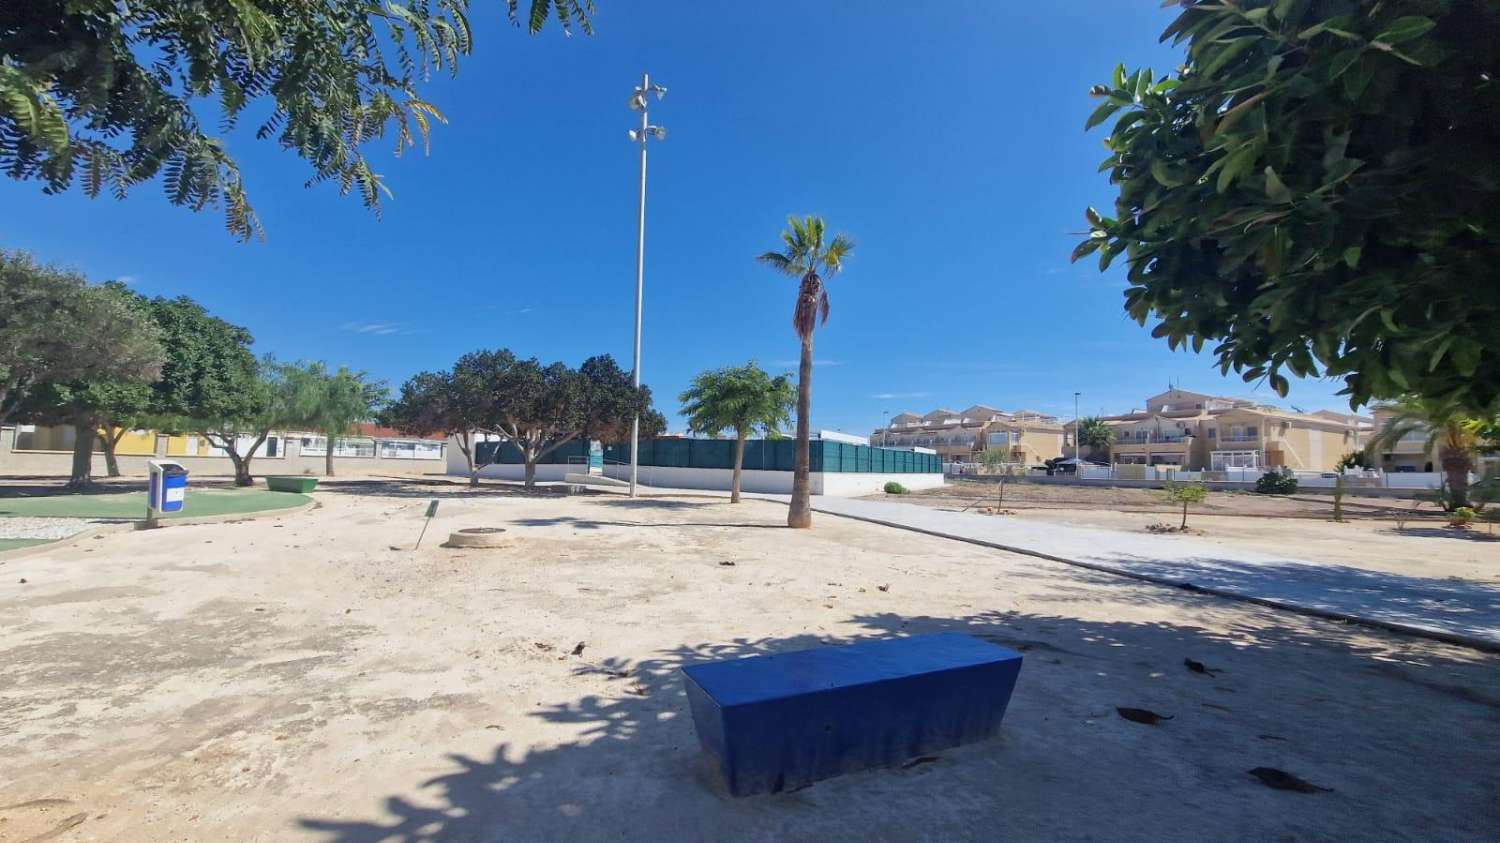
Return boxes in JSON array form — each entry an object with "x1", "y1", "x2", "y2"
[{"x1": 0, "y1": 0, "x2": 593, "y2": 239}]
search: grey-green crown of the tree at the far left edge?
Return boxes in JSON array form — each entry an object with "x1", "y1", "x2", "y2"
[{"x1": 0, "y1": 249, "x2": 161, "y2": 423}]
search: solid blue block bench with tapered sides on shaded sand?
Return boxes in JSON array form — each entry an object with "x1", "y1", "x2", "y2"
[{"x1": 683, "y1": 633, "x2": 1022, "y2": 797}]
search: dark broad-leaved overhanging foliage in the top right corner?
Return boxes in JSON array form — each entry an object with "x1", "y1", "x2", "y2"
[{"x1": 1074, "y1": 0, "x2": 1500, "y2": 417}]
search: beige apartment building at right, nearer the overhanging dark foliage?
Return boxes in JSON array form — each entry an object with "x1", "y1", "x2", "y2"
[{"x1": 1064, "y1": 389, "x2": 1374, "y2": 471}]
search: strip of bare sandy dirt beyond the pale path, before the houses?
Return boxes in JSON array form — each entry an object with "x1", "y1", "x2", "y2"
[{"x1": 888, "y1": 483, "x2": 1500, "y2": 584}]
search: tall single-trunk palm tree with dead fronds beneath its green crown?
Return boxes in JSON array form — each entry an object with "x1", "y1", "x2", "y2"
[{"x1": 756, "y1": 215, "x2": 854, "y2": 527}]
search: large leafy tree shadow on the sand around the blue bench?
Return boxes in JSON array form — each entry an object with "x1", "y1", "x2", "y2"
[{"x1": 299, "y1": 594, "x2": 1500, "y2": 843}]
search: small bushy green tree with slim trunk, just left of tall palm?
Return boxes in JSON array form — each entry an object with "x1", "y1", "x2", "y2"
[{"x1": 678, "y1": 360, "x2": 797, "y2": 504}]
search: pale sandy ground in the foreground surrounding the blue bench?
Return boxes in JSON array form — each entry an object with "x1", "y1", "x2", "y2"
[{"x1": 0, "y1": 483, "x2": 1500, "y2": 843}]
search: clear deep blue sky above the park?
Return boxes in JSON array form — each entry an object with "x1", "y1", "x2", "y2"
[{"x1": 0, "y1": 0, "x2": 1362, "y2": 432}]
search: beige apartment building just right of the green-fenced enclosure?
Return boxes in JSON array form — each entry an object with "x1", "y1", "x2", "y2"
[{"x1": 870, "y1": 404, "x2": 1064, "y2": 465}]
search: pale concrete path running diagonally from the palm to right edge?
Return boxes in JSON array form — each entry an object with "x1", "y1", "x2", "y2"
[{"x1": 804, "y1": 495, "x2": 1500, "y2": 651}]
